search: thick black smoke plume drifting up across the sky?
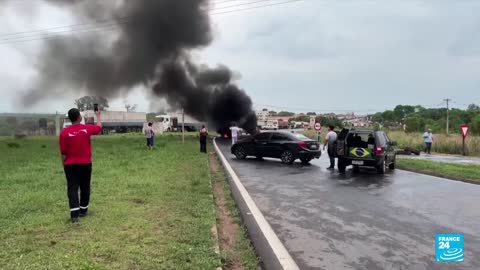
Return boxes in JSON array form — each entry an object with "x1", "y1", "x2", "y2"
[{"x1": 6, "y1": 0, "x2": 256, "y2": 132}]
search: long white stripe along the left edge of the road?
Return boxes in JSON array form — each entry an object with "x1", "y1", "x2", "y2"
[{"x1": 213, "y1": 139, "x2": 300, "y2": 270}]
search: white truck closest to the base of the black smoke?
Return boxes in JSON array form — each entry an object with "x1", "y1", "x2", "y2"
[{"x1": 155, "y1": 113, "x2": 207, "y2": 131}]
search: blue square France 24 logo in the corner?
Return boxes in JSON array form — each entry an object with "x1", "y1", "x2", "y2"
[{"x1": 435, "y1": 233, "x2": 464, "y2": 262}]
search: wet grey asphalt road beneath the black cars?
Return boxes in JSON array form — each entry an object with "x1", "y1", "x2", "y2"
[{"x1": 217, "y1": 140, "x2": 480, "y2": 270}]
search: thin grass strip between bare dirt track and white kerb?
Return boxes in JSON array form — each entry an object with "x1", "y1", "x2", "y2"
[{"x1": 212, "y1": 153, "x2": 258, "y2": 270}]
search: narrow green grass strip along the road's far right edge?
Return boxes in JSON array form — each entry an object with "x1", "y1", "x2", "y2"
[{"x1": 397, "y1": 159, "x2": 480, "y2": 184}]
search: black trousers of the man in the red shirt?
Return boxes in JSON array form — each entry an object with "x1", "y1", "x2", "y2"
[{"x1": 64, "y1": 164, "x2": 92, "y2": 218}]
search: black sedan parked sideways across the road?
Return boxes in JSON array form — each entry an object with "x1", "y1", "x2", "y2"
[{"x1": 231, "y1": 131, "x2": 322, "y2": 164}]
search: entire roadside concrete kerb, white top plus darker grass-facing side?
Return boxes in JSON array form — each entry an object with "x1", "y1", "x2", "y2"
[{"x1": 213, "y1": 139, "x2": 299, "y2": 270}]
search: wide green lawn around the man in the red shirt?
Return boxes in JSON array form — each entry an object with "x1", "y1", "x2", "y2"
[{"x1": 0, "y1": 136, "x2": 220, "y2": 269}]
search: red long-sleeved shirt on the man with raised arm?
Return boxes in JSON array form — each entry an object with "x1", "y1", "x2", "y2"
[{"x1": 60, "y1": 124, "x2": 102, "y2": 165}]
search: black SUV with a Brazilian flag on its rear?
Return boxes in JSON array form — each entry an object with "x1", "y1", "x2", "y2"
[{"x1": 336, "y1": 129, "x2": 396, "y2": 174}]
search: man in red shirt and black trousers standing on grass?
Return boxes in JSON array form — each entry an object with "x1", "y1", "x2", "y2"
[{"x1": 60, "y1": 109, "x2": 102, "y2": 223}]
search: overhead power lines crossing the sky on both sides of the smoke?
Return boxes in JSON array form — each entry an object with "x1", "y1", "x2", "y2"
[{"x1": 0, "y1": 0, "x2": 303, "y2": 45}]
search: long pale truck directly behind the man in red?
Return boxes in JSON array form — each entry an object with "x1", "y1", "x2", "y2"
[{"x1": 63, "y1": 111, "x2": 147, "y2": 134}]
